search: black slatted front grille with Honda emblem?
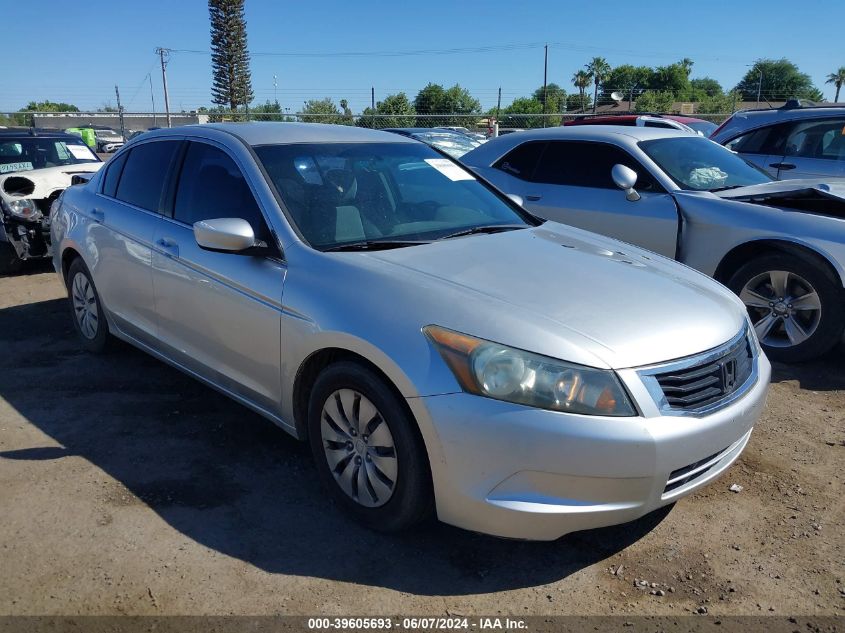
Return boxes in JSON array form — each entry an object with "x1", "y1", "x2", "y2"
[{"x1": 654, "y1": 336, "x2": 754, "y2": 411}]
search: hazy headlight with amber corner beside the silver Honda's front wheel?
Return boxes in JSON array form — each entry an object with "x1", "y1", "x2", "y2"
[{"x1": 423, "y1": 325, "x2": 636, "y2": 416}]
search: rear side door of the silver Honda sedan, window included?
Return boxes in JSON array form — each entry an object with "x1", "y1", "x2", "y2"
[{"x1": 88, "y1": 140, "x2": 181, "y2": 346}]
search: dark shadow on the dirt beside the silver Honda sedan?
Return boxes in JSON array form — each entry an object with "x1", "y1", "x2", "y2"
[{"x1": 0, "y1": 299, "x2": 671, "y2": 596}]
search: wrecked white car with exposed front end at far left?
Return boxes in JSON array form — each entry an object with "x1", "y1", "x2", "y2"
[{"x1": 0, "y1": 128, "x2": 103, "y2": 274}]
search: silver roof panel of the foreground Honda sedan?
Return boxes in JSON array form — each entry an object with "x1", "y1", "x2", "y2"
[{"x1": 144, "y1": 121, "x2": 419, "y2": 146}]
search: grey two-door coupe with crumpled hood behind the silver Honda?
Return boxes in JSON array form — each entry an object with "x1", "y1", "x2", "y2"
[{"x1": 461, "y1": 126, "x2": 845, "y2": 362}]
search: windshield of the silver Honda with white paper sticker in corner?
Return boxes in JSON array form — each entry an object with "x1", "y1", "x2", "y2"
[{"x1": 255, "y1": 143, "x2": 539, "y2": 250}]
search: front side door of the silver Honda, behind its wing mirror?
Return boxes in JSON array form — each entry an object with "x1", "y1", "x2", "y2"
[{"x1": 153, "y1": 141, "x2": 286, "y2": 414}]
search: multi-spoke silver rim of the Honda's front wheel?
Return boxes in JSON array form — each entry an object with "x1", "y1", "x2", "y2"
[{"x1": 320, "y1": 389, "x2": 398, "y2": 508}]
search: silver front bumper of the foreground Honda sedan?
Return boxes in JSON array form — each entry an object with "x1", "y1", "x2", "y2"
[{"x1": 408, "y1": 354, "x2": 771, "y2": 540}]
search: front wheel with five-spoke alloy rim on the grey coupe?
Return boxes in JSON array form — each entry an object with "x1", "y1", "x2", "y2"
[{"x1": 728, "y1": 253, "x2": 845, "y2": 363}]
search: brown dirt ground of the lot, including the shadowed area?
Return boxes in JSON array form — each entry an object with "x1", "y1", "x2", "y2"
[{"x1": 0, "y1": 265, "x2": 845, "y2": 616}]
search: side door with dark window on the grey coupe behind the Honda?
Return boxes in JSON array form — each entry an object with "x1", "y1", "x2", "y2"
[{"x1": 525, "y1": 141, "x2": 678, "y2": 258}]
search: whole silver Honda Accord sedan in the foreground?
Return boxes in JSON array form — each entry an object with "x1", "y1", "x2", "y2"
[{"x1": 52, "y1": 123, "x2": 770, "y2": 539}]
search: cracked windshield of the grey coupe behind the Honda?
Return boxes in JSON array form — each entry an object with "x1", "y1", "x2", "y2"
[{"x1": 639, "y1": 136, "x2": 771, "y2": 191}]
